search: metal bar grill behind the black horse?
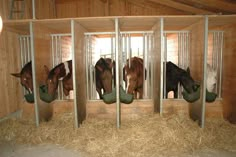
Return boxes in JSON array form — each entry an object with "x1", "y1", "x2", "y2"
[{"x1": 163, "y1": 31, "x2": 190, "y2": 99}]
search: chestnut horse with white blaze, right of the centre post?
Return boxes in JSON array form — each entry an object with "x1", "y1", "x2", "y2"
[{"x1": 123, "y1": 57, "x2": 146, "y2": 99}]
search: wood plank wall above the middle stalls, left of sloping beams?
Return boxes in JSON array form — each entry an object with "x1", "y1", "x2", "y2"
[{"x1": 55, "y1": 0, "x2": 188, "y2": 18}]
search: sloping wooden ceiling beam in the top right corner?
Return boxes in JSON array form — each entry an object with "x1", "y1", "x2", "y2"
[{"x1": 191, "y1": 0, "x2": 236, "y2": 13}]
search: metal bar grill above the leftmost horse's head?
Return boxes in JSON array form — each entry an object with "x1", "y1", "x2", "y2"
[{"x1": 18, "y1": 35, "x2": 31, "y2": 95}]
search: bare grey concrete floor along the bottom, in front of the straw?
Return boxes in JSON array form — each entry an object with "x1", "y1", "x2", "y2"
[{"x1": 0, "y1": 141, "x2": 236, "y2": 157}]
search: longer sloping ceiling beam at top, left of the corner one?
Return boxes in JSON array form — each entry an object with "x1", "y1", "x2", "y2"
[{"x1": 149, "y1": 0, "x2": 215, "y2": 14}]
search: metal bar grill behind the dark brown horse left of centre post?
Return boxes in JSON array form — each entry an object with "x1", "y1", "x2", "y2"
[{"x1": 85, "y1": 32, "x2": 115, "y2": 100}]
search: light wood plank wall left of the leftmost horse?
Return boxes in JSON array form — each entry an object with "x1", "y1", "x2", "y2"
[{"x1": 0, "y1": 31, "x2": 23, "y2": 118}]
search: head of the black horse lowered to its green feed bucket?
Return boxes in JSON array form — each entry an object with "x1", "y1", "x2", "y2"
[{"x1": 180, "y1": 67, "x2": 199, "y2": 93}]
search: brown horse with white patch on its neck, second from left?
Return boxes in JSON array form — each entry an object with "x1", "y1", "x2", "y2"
[{"x1": 44, "y1": 60, "x2": 73, "y2": 96}]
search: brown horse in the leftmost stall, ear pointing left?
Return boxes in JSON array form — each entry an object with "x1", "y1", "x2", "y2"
[{"x1": 11, "y1": 61, "x2": 33, "y2": 94}]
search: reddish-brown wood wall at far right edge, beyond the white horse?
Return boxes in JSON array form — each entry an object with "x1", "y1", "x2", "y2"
[{"x1": 222, "y1": 24, "x2": 236, "y2": 123}]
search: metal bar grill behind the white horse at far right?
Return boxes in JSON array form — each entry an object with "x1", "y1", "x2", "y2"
[{"x1": 207, "y1": 31, "x2": 224, "y2": 98}]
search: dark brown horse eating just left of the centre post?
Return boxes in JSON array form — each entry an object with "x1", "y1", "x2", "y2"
[{"x1": 95, "y1": 58, "x2": 116, "y2": 99}]
